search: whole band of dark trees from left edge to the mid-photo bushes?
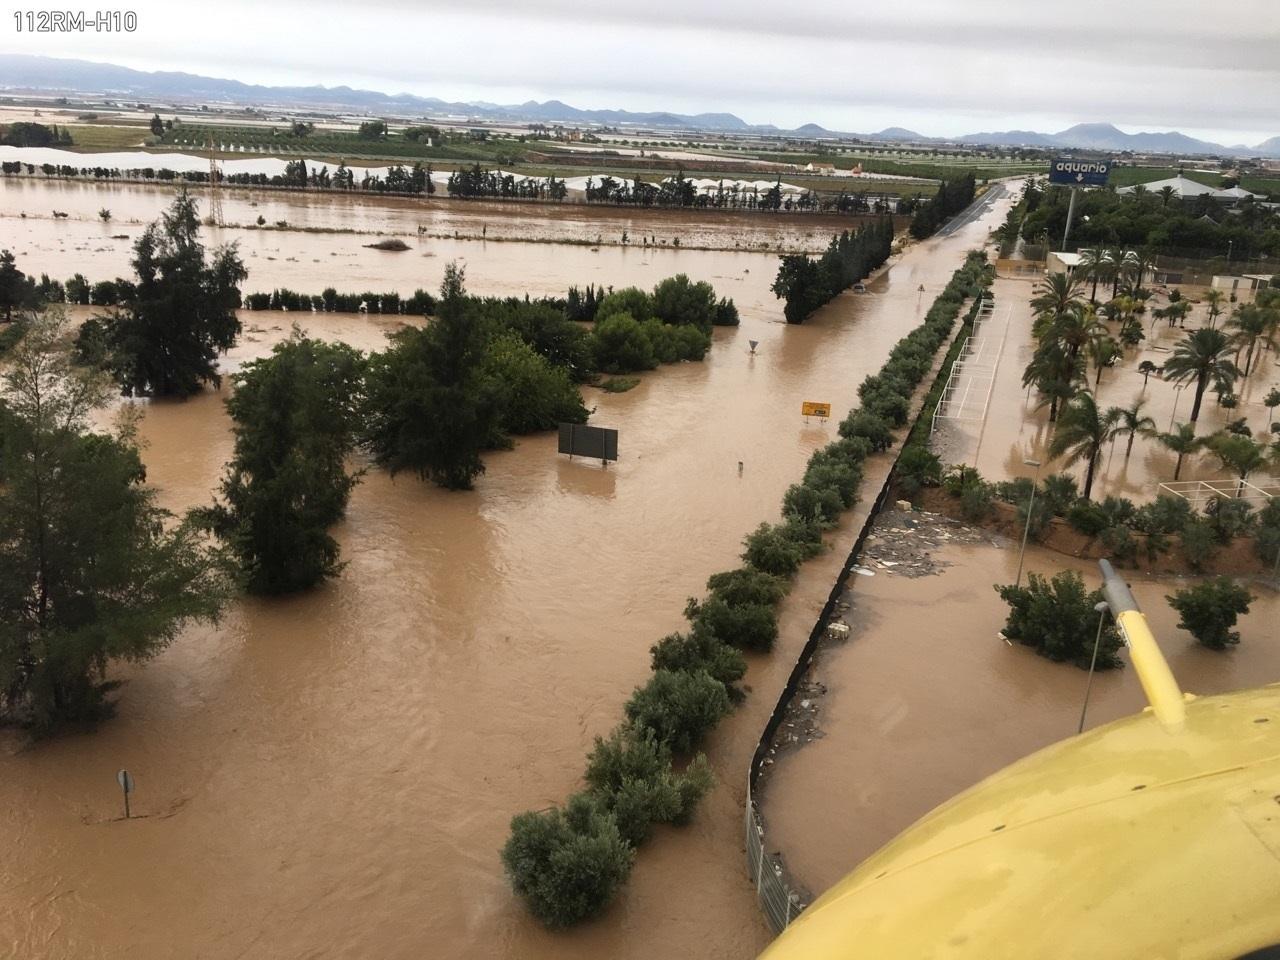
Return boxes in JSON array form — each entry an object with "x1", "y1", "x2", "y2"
[{"x1": 0, "y1": 195, "x2": 731, "y2": 731}]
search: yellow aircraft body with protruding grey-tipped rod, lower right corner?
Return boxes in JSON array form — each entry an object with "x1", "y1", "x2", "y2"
[{"x1": 762, "y1": 686, "x2": 1280, "y2": 960}]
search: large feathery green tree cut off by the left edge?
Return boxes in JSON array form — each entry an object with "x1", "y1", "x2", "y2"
[{"x1": 0, "y1": 314, "x2": 228, "y2": 730}]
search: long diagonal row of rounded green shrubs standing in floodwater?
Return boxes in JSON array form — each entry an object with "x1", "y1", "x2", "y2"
[{"x1": 502, "y1": 253, "x2": 989, "y2": 927}]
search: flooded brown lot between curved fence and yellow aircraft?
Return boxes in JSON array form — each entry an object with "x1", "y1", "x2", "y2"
[{"x1": 764, "y1": 529, "x2": 1280, "y2": 893}]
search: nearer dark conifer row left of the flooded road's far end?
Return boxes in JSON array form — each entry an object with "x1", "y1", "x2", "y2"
[{"x1": 771, "y1": 218, "x2": 893, "y2": 324}]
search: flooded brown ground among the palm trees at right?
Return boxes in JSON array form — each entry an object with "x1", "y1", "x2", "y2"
[{"x1": 933, "y1": 273, "x2": 1280, "y2": 503}]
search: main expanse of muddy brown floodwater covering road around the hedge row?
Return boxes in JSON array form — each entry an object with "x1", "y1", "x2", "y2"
[{"x1": 0, "y1": 184, "x2": 1007, "y2": 959}]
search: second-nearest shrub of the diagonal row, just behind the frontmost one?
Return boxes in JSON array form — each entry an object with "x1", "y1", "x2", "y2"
[{"x1": 585, "y1": 724, "x2": 714, "y2": 846}]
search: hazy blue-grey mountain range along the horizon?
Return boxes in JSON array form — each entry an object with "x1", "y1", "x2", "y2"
[{"x1": 0, "y1": 54, "x2": 1280, "y2": 156}]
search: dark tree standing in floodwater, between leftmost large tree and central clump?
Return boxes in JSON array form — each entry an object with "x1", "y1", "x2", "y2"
[{"x1": 204, "y1": 330, "x2": 364, "y2": 594}]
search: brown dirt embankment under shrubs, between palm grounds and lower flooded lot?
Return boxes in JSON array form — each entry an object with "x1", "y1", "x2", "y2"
[{"x1": 915, "y1": 488, "x2": 1271, "y2": 577}]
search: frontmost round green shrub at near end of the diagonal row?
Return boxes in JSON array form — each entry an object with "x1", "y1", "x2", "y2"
[{"x1": 502, "y1": 794, "x2": 635, "y2": 928}]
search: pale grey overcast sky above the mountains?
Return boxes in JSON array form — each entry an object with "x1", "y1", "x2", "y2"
[{"x1": 10, "y1": 0, "x2": 1280, "y2": 145}]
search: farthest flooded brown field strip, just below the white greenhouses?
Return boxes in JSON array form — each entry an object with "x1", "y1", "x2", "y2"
[{"x1": 0, "y1": 174, "x2": 885, "y2": 253}]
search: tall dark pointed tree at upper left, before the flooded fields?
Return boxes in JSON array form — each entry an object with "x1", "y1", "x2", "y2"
[{"x1": 81, "y1": 192, "x2": 248, "y2": 397}]
